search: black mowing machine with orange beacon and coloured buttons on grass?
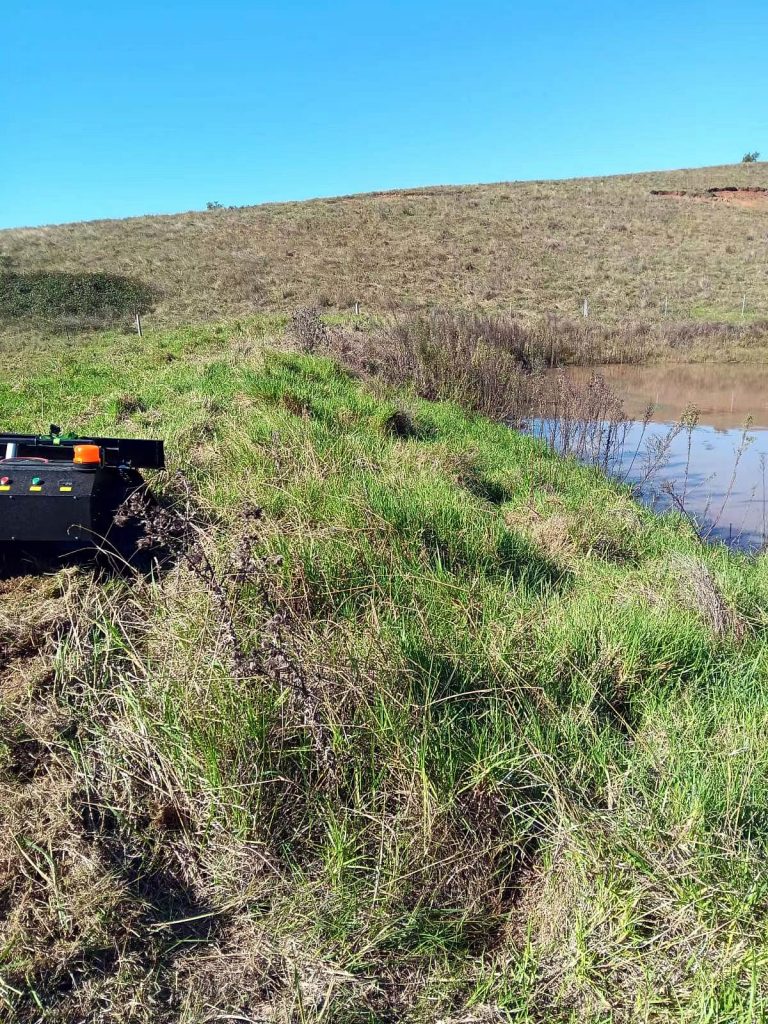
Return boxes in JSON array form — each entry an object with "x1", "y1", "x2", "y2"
[{"x1": 0, "y1": 424, "x2": 165, "y2": 559}]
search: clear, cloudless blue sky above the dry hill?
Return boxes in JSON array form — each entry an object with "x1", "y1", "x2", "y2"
[{"x1": 0, "y1": 0, "x2": 768, "y2": 226}]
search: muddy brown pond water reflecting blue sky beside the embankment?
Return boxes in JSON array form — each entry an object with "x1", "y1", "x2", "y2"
[{"x1": 566, "y1": 364, "x2": 768, "y2": 549}]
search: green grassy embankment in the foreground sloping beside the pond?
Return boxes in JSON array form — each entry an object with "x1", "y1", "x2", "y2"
[{"x1": 0, "y1": 322, "x2": 768, "y2": 1024}]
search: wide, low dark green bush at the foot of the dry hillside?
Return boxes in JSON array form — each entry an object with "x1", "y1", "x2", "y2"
[{"x1": 0, "y1": 269, "x2": 155, "y2": 328}]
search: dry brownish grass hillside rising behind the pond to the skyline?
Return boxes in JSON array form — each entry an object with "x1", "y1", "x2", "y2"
[{"x1": 0, "y1": 164, "x2": 768, "y2": 323}]
